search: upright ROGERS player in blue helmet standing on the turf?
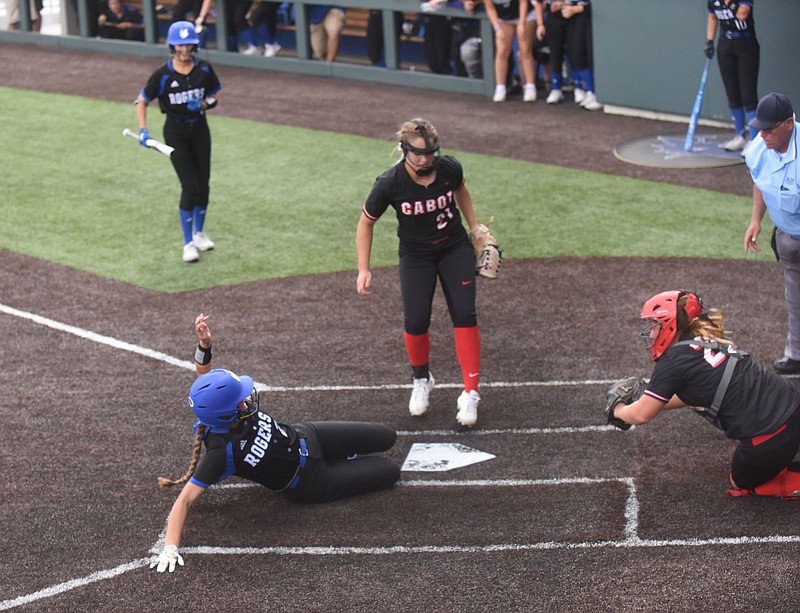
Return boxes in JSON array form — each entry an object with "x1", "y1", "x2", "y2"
[{"x1": 135, "y1": 21, "x2": 222, "y2": 262}]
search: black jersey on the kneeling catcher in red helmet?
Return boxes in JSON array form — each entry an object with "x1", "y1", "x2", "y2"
[{"x1": 645, "y1": 335, "x2": 800, "y2": 439}]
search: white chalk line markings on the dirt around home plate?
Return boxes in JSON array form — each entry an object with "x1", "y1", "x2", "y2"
[{"x1": 0, "y1": 304, "x2": 800, "y2": 611}]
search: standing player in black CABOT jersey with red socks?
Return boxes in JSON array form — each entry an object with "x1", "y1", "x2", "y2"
[{"x1": 356, "y1": 119, "x2": 480, "y2": 427}]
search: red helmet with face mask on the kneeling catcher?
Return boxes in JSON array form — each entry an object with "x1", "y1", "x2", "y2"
[{"x1": 641, "y1": 290, "x2": 703, "y2": 362}]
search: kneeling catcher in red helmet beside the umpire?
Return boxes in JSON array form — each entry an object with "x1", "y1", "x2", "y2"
[{"x1": 610, "y1": 290, "x2": 800, "y2": 498}]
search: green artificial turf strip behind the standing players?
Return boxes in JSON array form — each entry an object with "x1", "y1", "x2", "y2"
[{"x1": 0, "y1": 88, "x2": 772, "y2": 292}]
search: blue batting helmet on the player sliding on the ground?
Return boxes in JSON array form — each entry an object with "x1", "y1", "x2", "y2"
[{"x1": 189, "y1": 368, "x2": 258, "y2": 427}]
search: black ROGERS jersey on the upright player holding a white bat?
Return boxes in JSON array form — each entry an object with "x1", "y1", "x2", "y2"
[{"x1": 140, "y1": 58, "x2": 222, "y2": 119}]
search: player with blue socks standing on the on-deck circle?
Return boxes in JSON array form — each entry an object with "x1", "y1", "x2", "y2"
[{"x1": 705, "y1": 0, "x2": 761, "y2": 151}]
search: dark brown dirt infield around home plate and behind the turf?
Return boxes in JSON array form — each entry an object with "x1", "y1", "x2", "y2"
[{"x1": 0, "y1": 40, "x2": 800, "y2": 613}]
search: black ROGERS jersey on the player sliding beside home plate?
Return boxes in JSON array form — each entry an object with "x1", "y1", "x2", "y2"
[{"x1": 190, "y1": 411, "x2": 300, "y2": 490}]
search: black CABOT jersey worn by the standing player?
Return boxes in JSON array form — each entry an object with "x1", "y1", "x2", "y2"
[{"x1": 363, "y1": 155, "x2": 467, "y2": 245}]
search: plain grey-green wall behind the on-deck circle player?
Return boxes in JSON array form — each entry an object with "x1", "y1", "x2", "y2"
[{"x1": 592, "y1": 0, "x2": 800, "y2": 122}]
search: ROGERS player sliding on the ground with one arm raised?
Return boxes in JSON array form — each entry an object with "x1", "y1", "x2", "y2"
[{"x1": 150, "y1": 313, "x2": 400, "y2": 572}]
